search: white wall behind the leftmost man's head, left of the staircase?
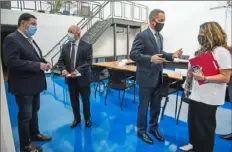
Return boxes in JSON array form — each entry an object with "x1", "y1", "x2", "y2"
[{"x1": 1, "y1": 9, "x2": 82, "y2": 55}]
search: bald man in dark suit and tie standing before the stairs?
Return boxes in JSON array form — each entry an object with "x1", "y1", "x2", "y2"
[{"x1": 58, "y1": 25, "x2": 93, "y2": 128}]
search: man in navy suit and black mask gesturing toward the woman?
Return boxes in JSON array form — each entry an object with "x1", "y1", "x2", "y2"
[{"x1": 130, "y1": 9, "x2": 182, "y2": 144}]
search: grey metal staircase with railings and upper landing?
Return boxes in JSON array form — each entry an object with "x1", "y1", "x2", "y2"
[{"x1": 44, "y1": 1, "x2": 148, "y2": 74}]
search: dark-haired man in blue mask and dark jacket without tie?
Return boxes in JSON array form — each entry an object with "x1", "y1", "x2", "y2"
[{"x1": 3, "y1": 13, "x2": 51, "y2": 152}]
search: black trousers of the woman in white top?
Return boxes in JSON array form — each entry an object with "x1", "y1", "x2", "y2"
[{"x1": 188, "y1": 100, "x2": 218, "y2": 152}]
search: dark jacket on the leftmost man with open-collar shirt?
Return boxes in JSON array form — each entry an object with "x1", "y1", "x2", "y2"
[{"x1": 3, "y1": 30, "x2": 47, "y2": 95}]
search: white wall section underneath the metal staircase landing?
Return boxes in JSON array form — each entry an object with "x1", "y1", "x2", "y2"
[{"x1": 93, "y1": 27, "x2": 140, "y2": 58}]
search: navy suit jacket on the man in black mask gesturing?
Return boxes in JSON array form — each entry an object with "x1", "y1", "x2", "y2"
[{"x1": 130, "y1": 28, "x2": 173, "y2": 87}]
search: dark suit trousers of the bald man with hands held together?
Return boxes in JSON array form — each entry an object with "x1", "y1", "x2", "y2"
[{"x1": 68, "y1": 78, "x2": 90, "y2": 120}]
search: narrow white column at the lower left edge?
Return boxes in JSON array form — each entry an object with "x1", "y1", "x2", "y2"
[{"x1": 0, "y1": 64, "x2": 15, "y2": 152}]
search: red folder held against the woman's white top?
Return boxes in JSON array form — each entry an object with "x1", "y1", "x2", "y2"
[{"x1": 189, "y1": 51, "x2": 219, "y2": 85}]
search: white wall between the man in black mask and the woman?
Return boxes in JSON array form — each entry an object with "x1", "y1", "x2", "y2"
[{"x1": 133, "y1": 1, "x2": 231, "y2": 55}]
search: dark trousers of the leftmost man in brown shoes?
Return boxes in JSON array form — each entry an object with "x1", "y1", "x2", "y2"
[{"x1": 15, "y1": 93, "x2": 40, "y2": 149}]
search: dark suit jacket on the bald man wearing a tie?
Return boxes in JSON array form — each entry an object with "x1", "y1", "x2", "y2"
[{"x1": 57, "y1": 40, "x2": 93, "y2": 86}]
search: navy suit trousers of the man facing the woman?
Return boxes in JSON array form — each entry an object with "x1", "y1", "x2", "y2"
[{"x1": 137, "y1": 78, "x2": 162, "y2": 134}]
